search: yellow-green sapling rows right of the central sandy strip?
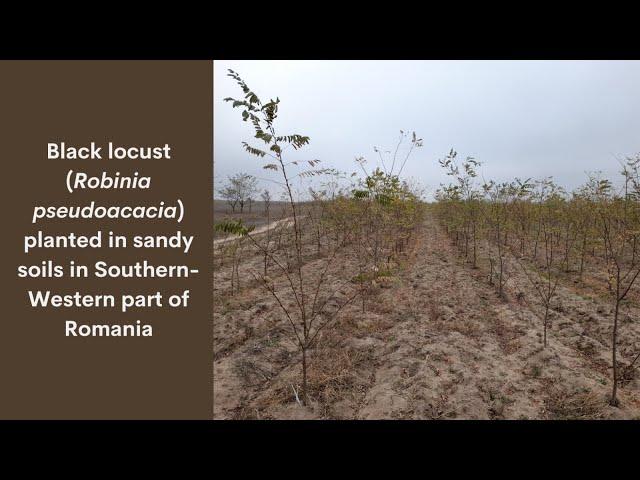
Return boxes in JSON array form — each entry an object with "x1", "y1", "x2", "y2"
[{"x1": 435, "y1": 150, "x2": 640, "y2": 406}]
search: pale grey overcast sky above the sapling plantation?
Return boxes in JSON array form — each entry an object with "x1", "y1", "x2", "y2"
[{"x1": 214, "y1": 61, "x2": 640, "y2": 199}]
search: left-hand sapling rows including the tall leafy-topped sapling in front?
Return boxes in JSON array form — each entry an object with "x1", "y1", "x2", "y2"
[{"x1": 216, "y1": 71, "x2": 423, "y2": 404}]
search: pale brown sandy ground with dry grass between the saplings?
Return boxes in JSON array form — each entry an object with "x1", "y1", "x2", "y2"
[{"x1": 214, "y1": 212, "x2": 640, "y2": 419}]
